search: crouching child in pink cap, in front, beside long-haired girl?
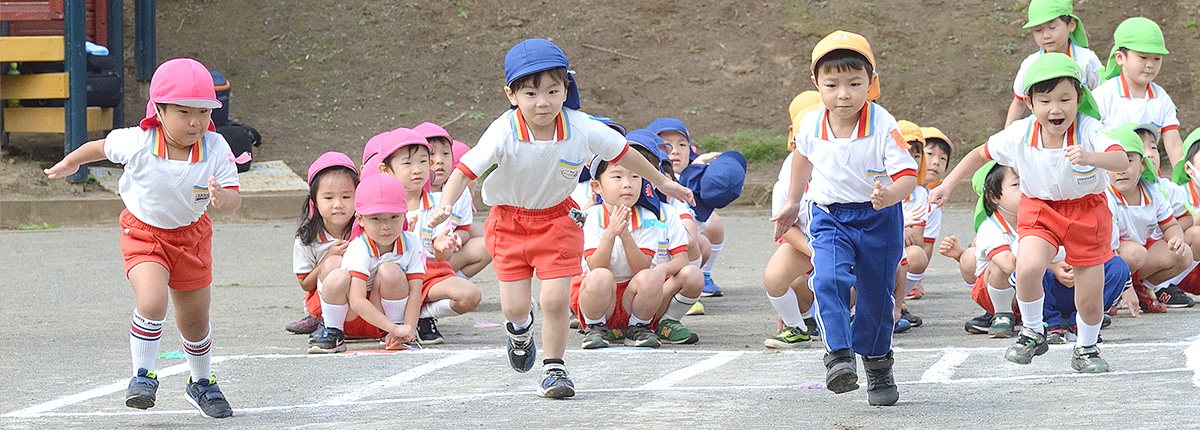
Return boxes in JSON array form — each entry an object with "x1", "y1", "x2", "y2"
[{"x1": 308, "y1": 174, "x2": 425, "y2": 353}]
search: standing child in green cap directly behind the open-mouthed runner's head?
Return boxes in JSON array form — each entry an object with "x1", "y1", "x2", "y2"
[{"x1": 1004, "y1": 0, "x2": 1103, "y2": 126}]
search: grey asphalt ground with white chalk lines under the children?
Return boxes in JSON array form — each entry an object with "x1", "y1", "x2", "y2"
[{"x1": 0, "y1": 205, "x2": 1200, "y2": 429}]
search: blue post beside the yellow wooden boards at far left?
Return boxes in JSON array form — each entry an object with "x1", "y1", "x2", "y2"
[{"x1": 62, "y1": 0, "x2": 88, "y2": 183}]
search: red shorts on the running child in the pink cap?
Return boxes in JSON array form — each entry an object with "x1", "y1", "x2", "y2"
[{"x1": 120, "y1": 209, "x2": 212, "y2": 291}]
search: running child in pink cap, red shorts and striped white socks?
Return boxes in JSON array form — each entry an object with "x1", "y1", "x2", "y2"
[{"x1": 44, "y1": 58, "x2": 241, "y2": 418}]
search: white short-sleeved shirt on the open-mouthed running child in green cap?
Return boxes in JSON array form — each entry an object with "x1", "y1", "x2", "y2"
[{"x1": 983, "y1": 114, "x2": 1124, "y2": 201}]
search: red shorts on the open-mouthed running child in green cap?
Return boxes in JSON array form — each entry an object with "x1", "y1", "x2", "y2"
[{"x1": 1016, "y1": 195, "x2": 1112, "y2": 267}]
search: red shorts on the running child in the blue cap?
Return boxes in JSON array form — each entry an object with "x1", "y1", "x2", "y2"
[{"x1": 484, "y1": 198, "x2": 583, "y2": 282}]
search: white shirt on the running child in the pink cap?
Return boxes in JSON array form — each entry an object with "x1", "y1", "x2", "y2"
[{"x1": 103, "y1": 127, "x2": 239, "y2": 229}]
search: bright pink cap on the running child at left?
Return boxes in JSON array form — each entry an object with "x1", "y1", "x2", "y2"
[{"x1": 138, "y1": 58, "x2": 221, "y2": 131}]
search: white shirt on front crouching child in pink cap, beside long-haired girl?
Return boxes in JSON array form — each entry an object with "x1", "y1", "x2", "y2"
[{"x1": 342, "y1": 232, "x2": 425, "y2": 291}]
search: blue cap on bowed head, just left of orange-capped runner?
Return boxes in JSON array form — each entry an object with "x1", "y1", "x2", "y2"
[{"x1": 679, "y1": 151, "x2": 746, "y2": 221}]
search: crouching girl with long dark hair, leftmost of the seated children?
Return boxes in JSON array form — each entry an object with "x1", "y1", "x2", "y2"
[{"x1": 287, "y1": 151, "x2": 359, "y2": 334}]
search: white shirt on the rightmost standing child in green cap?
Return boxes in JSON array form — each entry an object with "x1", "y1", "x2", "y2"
[{"x1": 1092, "y1": 73, "x2": 1180, "y2": 130}]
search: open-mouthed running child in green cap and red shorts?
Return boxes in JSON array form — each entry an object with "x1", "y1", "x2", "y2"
[{"x1": 930, "y1": 53, "x2": 1129, "y2": 371}]
